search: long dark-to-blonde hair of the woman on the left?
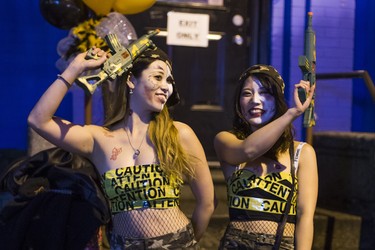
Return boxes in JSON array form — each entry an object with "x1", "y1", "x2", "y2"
[{"x1": 102, "y1": 49, "x2": 196, "y2": 181}]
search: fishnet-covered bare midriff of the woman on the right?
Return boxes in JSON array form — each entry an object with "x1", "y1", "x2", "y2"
[{"x1": 231, "y1": 220, "x2": 295, "y2": 237}]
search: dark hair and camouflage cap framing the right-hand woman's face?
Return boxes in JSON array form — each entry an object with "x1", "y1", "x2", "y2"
[{"x1": 231, "y1": 66, "x2": 294, "y2": 160}]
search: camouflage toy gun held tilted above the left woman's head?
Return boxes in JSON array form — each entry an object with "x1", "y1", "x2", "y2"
[{"x1": 76, "y1": 30, "x2": 159, "y2": 95}]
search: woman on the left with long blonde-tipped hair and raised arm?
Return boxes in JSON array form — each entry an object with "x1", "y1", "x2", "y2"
[{"x1": 28, "y1": 48, "x2": 214, "y2": 249}]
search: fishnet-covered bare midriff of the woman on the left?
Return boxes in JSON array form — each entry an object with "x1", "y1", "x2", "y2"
[{"x1": 113, "y1": 208, "x2": 189, "y2": 238}]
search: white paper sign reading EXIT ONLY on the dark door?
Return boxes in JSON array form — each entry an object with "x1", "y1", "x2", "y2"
[{"x1": 167, "y1": 11, "x2": 210, "y2": 47}]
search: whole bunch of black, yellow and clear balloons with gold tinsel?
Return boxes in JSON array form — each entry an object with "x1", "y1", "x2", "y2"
[{"x1": 39, "y1": 0, "x2": 156, "y2": 71}]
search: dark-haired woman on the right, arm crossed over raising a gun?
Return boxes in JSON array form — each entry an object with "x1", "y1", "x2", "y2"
[{"x1": 214, "y1": 65, "x2": 318, "y2": 250}]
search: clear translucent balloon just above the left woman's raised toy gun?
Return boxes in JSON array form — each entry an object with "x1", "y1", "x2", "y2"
[{"x1": 95, "y1": 12, "x2": 137, "y2": 46}]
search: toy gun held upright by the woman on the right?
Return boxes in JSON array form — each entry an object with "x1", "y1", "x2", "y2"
[{"x1": 298, "y1": 12, "x2": 316, "y2": 128}]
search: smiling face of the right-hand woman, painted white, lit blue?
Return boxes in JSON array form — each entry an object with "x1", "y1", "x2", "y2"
[{"x1": 240, "y1": 77, "x2": 276, "y2": 129}]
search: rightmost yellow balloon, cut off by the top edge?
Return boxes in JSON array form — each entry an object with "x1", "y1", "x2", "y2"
[{"x1": 113, "y1": 0, "x2": 156, "y2": 15}]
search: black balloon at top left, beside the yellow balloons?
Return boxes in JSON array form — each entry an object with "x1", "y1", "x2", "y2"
[{"x1": 39, "y1": 0, "x2": 89, "y2": 29}]
